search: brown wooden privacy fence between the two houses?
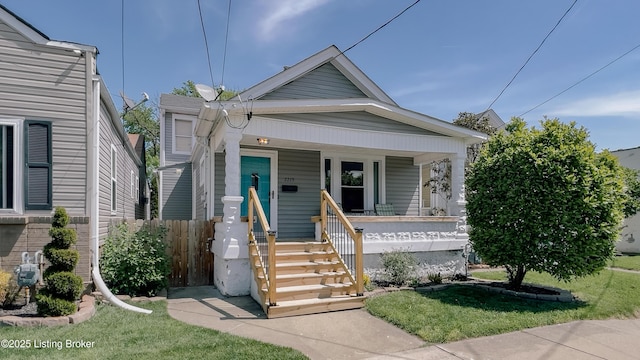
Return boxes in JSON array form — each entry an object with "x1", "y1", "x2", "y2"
[{"x1": 106, "y1": 220, "x2": 214, "y2": 287}]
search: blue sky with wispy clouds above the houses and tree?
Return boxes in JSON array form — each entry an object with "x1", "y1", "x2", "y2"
[{"x1": 1, "y1": 0, "x2": 640, "y2": 150}]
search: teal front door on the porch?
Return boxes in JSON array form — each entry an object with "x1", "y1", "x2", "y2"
[{"x1": 240, "y1": 155, "x2": 271, "y2": 221}]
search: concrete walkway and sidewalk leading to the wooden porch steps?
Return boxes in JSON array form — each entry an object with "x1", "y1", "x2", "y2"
[{"x1": 167, "y1": 286, "x2": 640, "y2": 360}]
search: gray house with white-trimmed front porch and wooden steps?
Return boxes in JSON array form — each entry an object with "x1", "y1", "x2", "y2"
[{"x1": 160, "y1": 46, "x2": 486, "y2": 317}]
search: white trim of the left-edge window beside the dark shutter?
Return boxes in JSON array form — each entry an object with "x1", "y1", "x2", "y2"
[{"x1": 0, "y1": 118, "x2": 24, "y2": 215}]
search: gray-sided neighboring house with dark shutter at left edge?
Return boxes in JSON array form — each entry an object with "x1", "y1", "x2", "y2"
[{"x1": 0, "y1": 5, "x2": 146, "y2": 281}]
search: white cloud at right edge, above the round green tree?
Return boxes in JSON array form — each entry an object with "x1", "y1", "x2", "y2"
[{"x1": 549, "y1": 90, "x2": 640, "y2": 117}]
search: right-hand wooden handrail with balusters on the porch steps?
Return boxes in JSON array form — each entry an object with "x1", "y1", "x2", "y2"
[{"x1": 320, "y1": 189, "x2": 364, "y2": 296}]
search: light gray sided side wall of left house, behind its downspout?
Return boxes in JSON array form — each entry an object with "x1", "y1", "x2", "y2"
[{"x1": 99, "y1": 106, "x2": 139, "y2": 238}]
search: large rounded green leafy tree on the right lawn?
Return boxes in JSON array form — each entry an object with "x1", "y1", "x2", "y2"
[{"x1": 466, "y1": 118, "x2": 628, "y2": 289}]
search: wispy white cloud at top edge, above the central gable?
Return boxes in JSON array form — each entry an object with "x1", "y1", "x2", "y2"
[{"x1": 258, "y1": 0, "x2": 330, "y2": 41}]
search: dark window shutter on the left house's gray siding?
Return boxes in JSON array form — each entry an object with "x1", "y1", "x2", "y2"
[{"x1": 24, "y1": 120, "x2": 52, "y2": 210}]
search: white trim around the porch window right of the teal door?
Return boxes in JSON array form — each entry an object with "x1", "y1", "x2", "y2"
[{"x1": 320, "y1": 152, "x2": 387, "y2": 210}]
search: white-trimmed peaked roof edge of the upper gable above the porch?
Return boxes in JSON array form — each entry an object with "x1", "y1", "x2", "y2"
[{"x1": 240, "y1": 45, "x2": 397, "y2": 106}]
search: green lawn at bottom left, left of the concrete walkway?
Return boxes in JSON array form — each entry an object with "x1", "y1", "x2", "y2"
[{"x1": 0, "y1": 301, "x2": 306, "y2": 359}]
